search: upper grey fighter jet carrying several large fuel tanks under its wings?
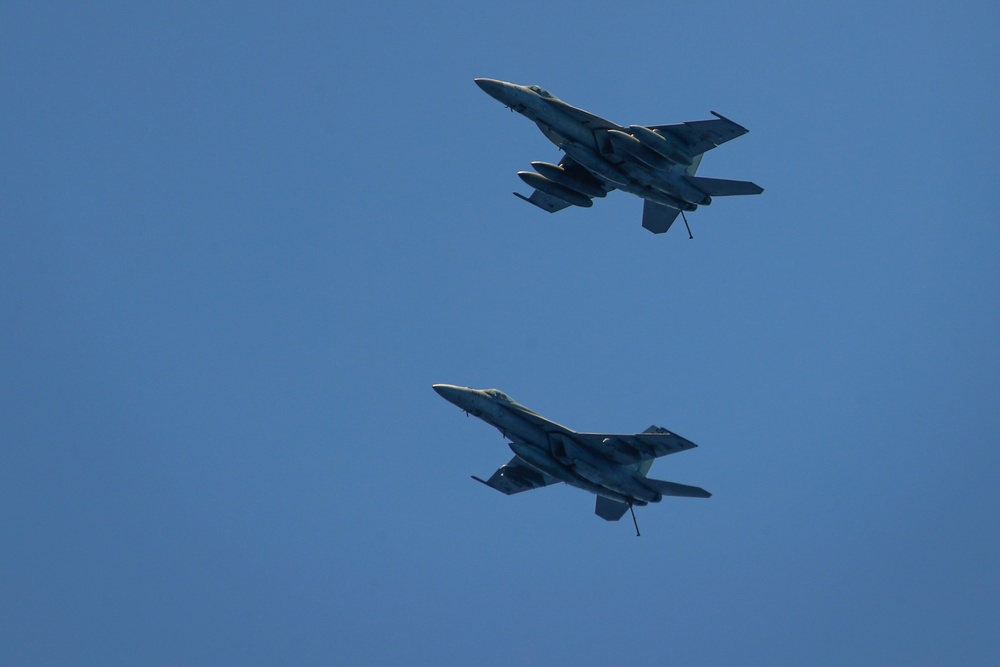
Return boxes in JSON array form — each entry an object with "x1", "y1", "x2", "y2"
[{"x1": 476, "y1": 79, "x2": 764, "y2": 238}]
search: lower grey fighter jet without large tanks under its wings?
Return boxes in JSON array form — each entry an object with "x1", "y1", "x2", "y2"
[{"x1": 433, "y1": 384, "x2": 712, "y2": 535}]
